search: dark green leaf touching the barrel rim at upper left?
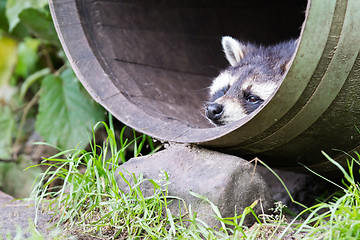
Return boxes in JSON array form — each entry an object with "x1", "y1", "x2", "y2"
[{"x1": 19, "y1": 8, "x2": 60, "y2": 46}]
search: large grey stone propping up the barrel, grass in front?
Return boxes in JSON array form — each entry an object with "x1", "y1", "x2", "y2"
[{"x1": 117, "y1": 144, "x2": 273, "y2": 227}]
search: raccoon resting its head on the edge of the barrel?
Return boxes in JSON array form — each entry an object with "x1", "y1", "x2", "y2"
[{"x1": 205, "y1": 36, "x2": 297, "y2": 126}]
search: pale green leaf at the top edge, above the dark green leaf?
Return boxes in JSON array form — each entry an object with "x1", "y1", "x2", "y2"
[{"x1": 6, "y1": 0, "x2": 48, "y2": 32}]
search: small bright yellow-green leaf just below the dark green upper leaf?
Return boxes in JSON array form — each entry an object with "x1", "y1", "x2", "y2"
[{"x1": 15, "y1": 38, "x2": 40, "y2": 78}]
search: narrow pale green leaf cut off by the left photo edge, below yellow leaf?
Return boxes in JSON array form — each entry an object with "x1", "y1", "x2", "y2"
[{"x1": 0, "y1": 106, "x2": 15, "y2": 159}]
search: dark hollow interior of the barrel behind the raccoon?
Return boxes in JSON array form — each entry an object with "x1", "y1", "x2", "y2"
[{"x1": 77, "y1": 0, "x2": 307, "y2": 131}]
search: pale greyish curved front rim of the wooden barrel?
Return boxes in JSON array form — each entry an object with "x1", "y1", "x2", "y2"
[{"x1": 49, "y1": 0, "x2": 318, "y2": 145}]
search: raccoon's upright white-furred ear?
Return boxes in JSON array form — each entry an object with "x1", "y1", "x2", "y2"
[{"x1": 221, "y1": 36, "x2": 245, "y2": 66}]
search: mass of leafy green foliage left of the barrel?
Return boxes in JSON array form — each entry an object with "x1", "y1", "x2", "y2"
[{"x1": 0, "y1": 0, "x2": 104, "y2": 159}]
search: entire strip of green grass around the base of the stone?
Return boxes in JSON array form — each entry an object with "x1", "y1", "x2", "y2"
[{"x1": 26, "y1": 121, "x2": 360, "y2": 239}]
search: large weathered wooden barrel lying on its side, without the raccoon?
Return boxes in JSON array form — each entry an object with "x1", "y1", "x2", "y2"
[{"x1": 50, "y1": 0, "x2": 360, "y2": 172}]
